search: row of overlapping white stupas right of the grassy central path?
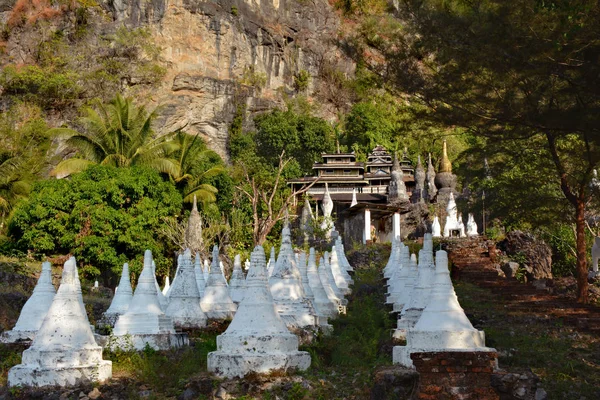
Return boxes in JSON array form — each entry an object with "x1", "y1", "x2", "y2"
[{"x1": 383, "y1": 234, "x2": 495, "y2": 368}]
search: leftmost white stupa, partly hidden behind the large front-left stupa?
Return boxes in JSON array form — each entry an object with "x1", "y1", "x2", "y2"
[{"x1": 0, "y1": 261, "x2": 56, "y2": 343}]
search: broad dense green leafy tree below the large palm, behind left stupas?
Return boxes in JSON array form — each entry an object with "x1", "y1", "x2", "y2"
[{"x1": 9, "y1": 166, "x2": 182, "y2": 283}]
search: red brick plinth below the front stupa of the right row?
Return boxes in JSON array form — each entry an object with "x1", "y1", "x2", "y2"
[{"x1": 410, "y1": 351, "x2": 499, "y2": 400}]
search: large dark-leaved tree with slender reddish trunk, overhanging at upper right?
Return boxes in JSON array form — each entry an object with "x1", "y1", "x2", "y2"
[{"x1": 363, "y1": 0, "x2": 600, "y2": 303}]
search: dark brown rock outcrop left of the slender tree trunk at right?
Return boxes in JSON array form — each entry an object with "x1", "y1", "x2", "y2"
[{"x1": 498, "y1": 231, "x2": 552, "y2": 280}]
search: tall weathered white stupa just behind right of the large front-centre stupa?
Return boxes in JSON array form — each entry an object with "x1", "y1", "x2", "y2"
[{"x1": 269, "y1": 221, "x2": 318, "y2": 329}]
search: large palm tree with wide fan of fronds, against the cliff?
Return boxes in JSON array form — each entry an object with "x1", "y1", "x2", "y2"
[{"x1": 51, "y1": 94, "x2": 177, "y2": 178}]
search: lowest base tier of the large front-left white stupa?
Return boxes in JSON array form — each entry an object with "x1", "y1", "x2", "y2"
[{"x1": 8, "y1": 360, "x2": 112, "y2": 387}]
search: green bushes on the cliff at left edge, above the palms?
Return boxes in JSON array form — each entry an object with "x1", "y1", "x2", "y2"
[{"x1": 0, "y1": 65, "x2": 82, "y2": 109}]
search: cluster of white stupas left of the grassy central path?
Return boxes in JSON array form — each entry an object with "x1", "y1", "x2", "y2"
[{"x1": 5, "y1": 226, "x2": 352, "y2": 386}]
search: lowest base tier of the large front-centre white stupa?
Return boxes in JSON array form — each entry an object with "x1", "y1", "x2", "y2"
[{"x1": 208, "y1": 351, "x2": 310, "y2": 378}]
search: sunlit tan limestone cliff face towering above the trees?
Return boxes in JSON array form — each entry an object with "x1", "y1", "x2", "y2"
[{"x1": 2, "y1": 0, "x2": 353, "y2": 161}]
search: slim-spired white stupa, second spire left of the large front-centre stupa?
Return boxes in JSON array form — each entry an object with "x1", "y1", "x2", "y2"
[{"x1": 200, "y1": 245, "x2": 237, "y2": 319}]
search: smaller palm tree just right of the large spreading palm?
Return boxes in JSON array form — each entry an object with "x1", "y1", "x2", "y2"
[{"x1": 171, "y1": 130, "x2": 225, "y2": 204}]
